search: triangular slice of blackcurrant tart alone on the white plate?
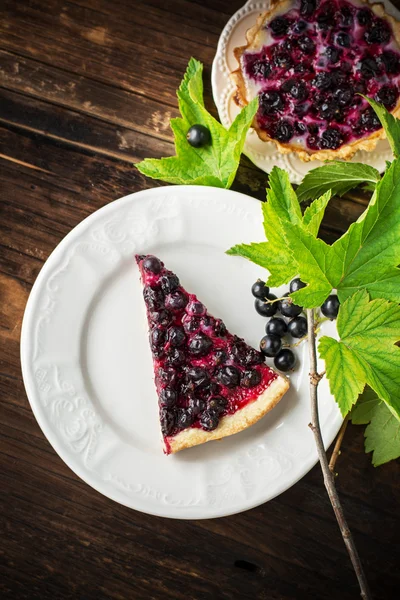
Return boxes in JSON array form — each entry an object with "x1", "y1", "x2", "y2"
[{"x1": 136, "y1": 255, "x2": 289, "y2": 454}]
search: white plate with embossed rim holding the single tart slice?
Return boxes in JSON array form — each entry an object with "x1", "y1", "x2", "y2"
[{"x1": 21, "y1": 186, "x2": 341, "y2": 519}]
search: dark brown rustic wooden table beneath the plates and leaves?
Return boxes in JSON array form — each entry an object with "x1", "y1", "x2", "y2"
[{"x1": 0, "y1": 0, "x2": 400, "y2": 600}]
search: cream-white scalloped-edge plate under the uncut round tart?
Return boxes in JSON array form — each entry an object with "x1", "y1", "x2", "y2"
[{"x1": 212, "y1": 0, "x2": 400, "y2": 183}]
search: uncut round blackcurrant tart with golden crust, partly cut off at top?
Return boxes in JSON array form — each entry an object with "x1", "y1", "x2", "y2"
[{"x1": 231, "y1": 0, "x2": 400, "y2": 161}]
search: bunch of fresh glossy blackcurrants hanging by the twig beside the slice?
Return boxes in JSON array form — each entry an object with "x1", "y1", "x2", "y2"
[{"x1": 251, "y1": 277, "x2": 339, "y2": 372}]
